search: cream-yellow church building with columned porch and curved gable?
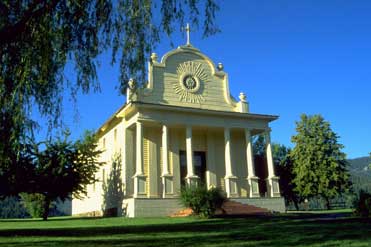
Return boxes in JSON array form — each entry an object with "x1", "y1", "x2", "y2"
[{"x1": 72, "y1": 36, "x2": 285, "y2": 217}]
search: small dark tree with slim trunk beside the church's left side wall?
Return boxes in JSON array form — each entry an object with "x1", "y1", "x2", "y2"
[{"x1": 27, "y1": 132, "x2": 102, "y2": 220}]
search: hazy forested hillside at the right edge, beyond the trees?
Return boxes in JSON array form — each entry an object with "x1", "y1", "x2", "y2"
[{"x1": 348, "y1": 157, "x2": 371, "y2": 192}]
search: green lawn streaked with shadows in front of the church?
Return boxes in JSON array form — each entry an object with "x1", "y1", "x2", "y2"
[{"x1": 0, "y1": 212, "x2": 371, "y2": 247}]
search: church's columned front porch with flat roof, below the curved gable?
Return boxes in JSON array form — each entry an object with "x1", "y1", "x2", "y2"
[{"x1": 122, "y1": 102, "x2": 280, "y2": 201}]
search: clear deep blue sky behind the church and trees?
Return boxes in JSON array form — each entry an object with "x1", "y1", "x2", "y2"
[{"x1": 50, "y1": 0, "x2": 371, "y2": 158}]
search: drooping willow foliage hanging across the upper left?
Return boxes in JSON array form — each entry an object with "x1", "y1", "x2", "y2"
[{"x1": 0, "y1": 0, "x2": 218, "y2": 197}]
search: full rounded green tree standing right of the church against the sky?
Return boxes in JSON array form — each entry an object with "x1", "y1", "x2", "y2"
[{"x1": 290, "y1": 114, "x2": 350, "y2": 209}]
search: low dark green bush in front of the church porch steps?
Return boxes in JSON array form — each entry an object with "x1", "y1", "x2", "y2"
[{"x1": 180, "y1": 185, "x2": 225, "y2": 218}]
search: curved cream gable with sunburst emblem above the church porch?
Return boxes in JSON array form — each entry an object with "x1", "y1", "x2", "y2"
[{"x1": 138, "y1": 46, "x2": 238, "y2": 111}]
